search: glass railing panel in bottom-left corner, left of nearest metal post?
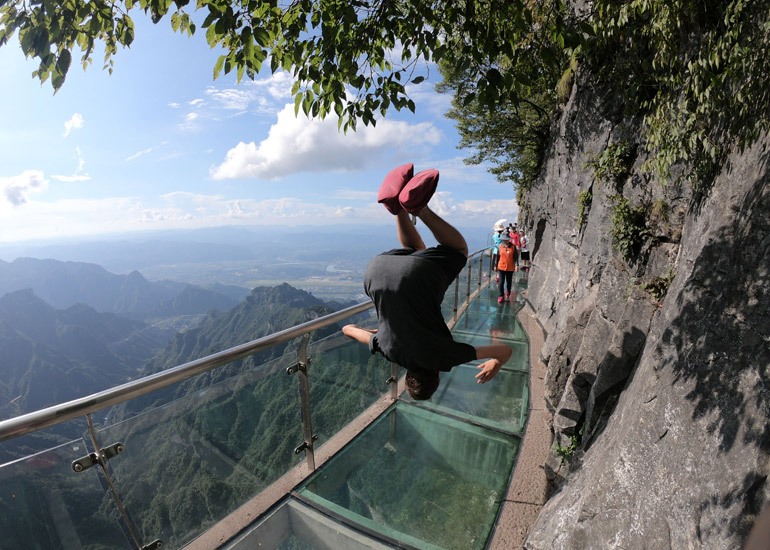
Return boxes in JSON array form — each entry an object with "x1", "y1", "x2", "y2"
[{"x1": 0, "y1": 438, "x2": 128, "y2": 550}]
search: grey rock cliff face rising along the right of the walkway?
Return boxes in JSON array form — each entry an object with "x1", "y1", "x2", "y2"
[{"x1": 524, "y1": 72, "x2": 770, "y2": 549}]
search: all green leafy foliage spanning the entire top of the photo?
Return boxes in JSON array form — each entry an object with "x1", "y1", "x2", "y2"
[{"x1": 0, "y1": 0, "x2": 770, "y2": 191}]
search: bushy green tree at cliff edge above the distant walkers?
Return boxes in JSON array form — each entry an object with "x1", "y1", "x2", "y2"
[{"x1": 438, "y1": 0, "x2": 568, "y2": 194}]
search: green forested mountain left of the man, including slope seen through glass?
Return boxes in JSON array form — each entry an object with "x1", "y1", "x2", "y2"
[{"x1": 94, "y1": 284, "x2": 388, "y2": 546}]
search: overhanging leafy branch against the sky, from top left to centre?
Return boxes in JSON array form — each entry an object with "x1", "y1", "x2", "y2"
[{"x1": 0, "y1": 0, "x2": 564, "y2": 129}]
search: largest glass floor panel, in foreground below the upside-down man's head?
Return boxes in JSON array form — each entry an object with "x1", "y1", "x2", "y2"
[{"x1": 297, "y1": 402, "x2": 520, "y2": 550}]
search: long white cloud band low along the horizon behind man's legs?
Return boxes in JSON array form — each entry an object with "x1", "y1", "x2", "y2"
[{"x1": 0, "y1": 188, "x2": 518, "y2": 242}]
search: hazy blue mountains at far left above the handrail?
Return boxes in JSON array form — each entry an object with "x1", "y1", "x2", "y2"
[{"x1": 0, "y1": 289, "x2": 173, "y2": 418}]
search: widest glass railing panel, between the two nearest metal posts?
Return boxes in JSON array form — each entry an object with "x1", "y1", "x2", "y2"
[{"x1": 98, "y1": 343, "x2": 304, "y2": 548}]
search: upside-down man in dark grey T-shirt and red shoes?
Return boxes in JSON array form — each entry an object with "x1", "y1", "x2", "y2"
[{"x1": 342, "y1": 164, "x2": 512, "y2": 400}]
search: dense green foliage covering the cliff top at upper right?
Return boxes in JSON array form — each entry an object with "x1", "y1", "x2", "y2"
[{"x1": 441, "y1": 0, "x2": 770, "y2": 199}]
